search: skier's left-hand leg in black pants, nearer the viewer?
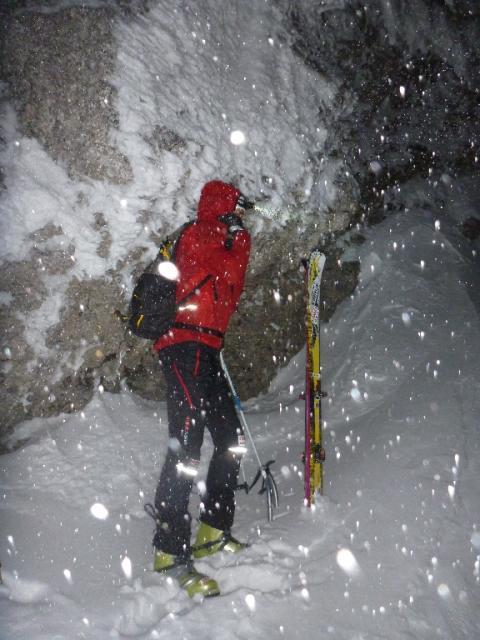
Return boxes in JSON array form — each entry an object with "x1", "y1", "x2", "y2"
[{"x1": 153, "y1": 343, "x2": 204, "y2": 557}]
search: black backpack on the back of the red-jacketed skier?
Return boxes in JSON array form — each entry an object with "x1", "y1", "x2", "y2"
[{"x1": 127, "y1": 223, "x2": 212, "y2": 340}]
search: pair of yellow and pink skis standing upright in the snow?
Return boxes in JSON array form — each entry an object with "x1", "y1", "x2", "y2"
[{"x1": 304, "y1": 249, "x2": 325, "y2": 507}]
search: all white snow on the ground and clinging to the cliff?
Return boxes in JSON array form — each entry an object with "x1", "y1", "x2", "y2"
[{"x1": 0, "y1": 0, "x2": 480, "y2": 640}]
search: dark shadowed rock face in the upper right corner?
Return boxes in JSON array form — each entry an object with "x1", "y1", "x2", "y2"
[{"x1": 286, "y1": 0, "x2": 480, "y2": 221}]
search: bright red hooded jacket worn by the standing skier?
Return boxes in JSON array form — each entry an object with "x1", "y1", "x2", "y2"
[{"x1": 154, "y1": 180, "x2": 250, "y2": 351}]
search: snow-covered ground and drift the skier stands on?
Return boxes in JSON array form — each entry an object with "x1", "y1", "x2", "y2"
[{"x1": 0, "y1": 204, "x2": 480, "y2": 640}]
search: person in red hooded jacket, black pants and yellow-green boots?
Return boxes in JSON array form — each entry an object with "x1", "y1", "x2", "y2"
[{"x1": 153, "y1": 180, "x2": 253, "y2": 596}]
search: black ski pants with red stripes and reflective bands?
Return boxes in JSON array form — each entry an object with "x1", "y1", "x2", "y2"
[{"x1": 153, "y1": 342, "x2": 243, "y2": 556}]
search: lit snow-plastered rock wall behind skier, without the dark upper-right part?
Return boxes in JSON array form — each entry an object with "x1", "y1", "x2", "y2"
[{"x1": 0, "y1": 0, "x2": 422, "y2": 440}]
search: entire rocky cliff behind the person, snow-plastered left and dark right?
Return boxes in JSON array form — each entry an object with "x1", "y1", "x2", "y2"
[{"x1": 0, "y1": 0, "x2": 480, "y2": 444}]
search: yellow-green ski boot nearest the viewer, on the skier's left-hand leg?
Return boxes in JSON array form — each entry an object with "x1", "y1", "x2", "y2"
[{"x1": 153, "y1": 549, "x2": 220, "y2": 598}]
